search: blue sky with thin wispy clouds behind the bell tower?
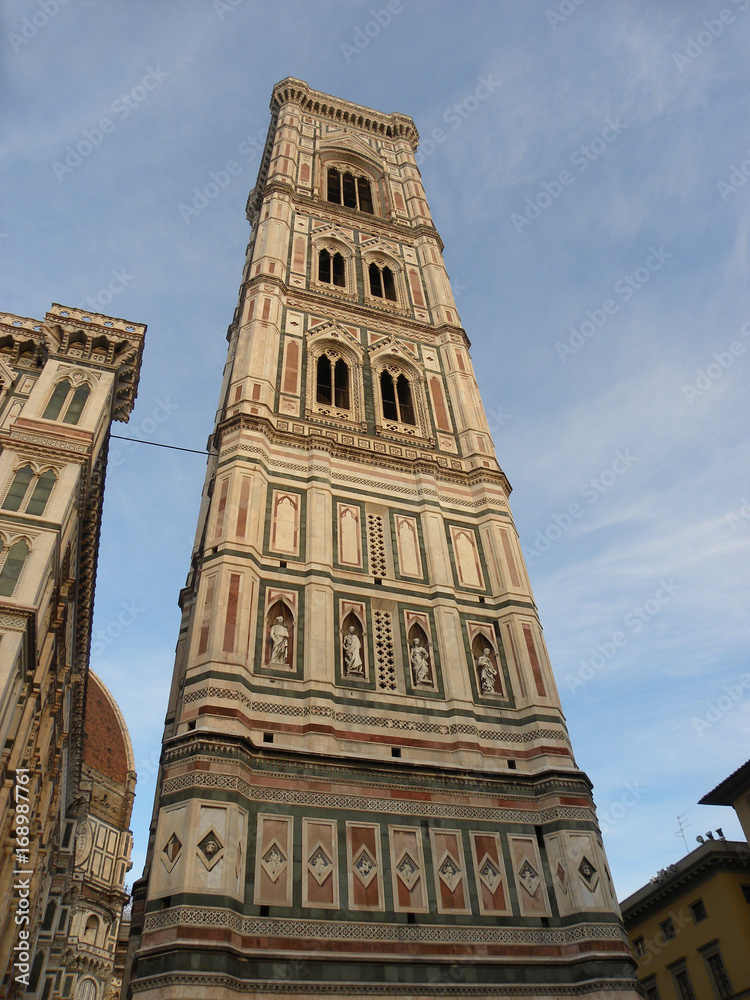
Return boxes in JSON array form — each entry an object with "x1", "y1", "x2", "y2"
[{"x1": 0, "y1": 0, "x2": 750, "y2": 898}]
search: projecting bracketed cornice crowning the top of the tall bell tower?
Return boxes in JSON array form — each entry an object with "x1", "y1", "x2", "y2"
[{"x1": 271, "y1": 76, "x2": 419, "y2": 150}]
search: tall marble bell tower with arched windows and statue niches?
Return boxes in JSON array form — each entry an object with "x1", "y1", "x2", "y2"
[{"x1": 129, "y1": 79, "x2": 636, "y2": 1000}]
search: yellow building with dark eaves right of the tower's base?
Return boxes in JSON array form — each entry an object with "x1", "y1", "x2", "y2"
[{"x1": 621, "y1": 840, "x2": 750, "y2": 1000}]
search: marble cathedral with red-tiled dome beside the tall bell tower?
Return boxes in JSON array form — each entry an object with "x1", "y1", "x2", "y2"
[{"x1": 0, "y1": 305, "x2": 145, "y2": 1000}]
